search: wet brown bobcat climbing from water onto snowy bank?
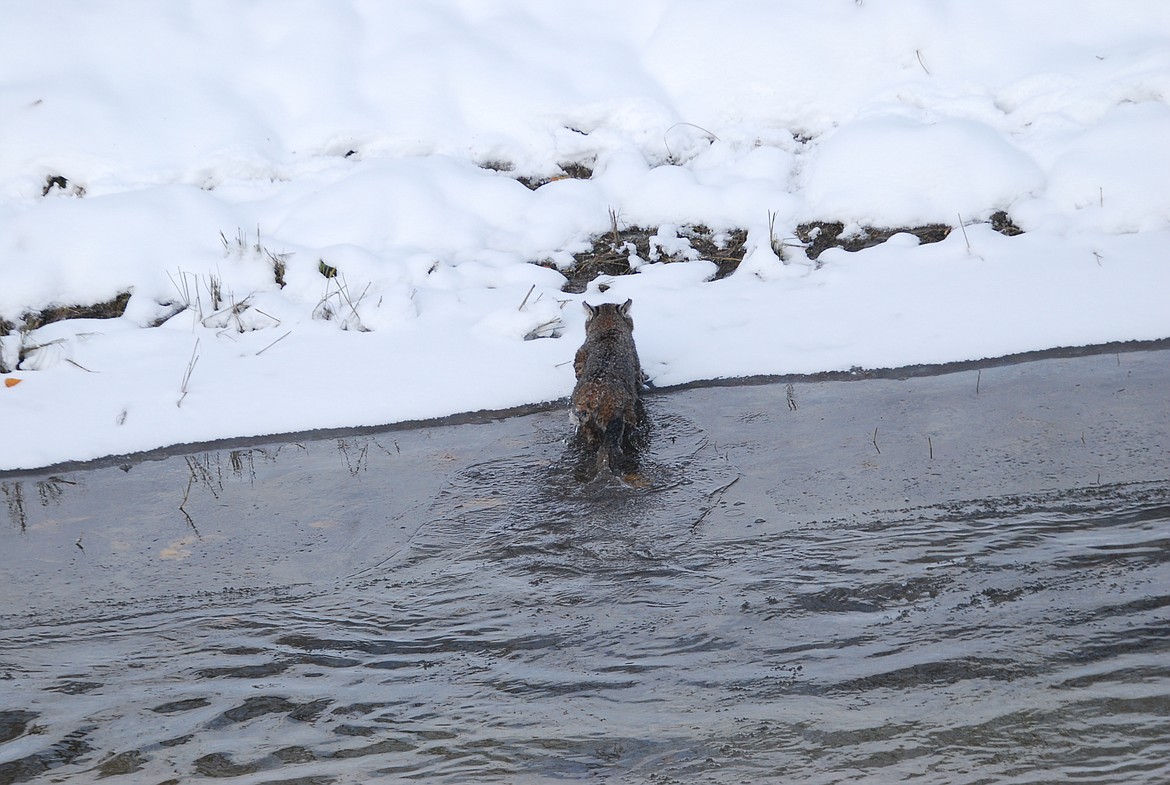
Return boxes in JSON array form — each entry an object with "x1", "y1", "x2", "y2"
[{"x1": 570, "y1": 299, "x2": 642, "y2": 471}]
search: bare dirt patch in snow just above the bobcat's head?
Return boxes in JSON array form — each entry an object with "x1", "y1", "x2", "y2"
[{"x1": 549, "y1": 226, "x2": 748, "y2": 294}]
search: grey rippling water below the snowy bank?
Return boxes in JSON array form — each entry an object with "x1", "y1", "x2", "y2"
[{"x1": 0, "y1": 352, "x2": 1170, "y2": 785}]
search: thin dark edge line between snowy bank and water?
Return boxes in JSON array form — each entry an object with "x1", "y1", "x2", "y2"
[{"x1": 0, "y1": 338, "x2": 1170, "y2": 480}]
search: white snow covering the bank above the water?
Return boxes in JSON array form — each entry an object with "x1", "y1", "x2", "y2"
[{"x1": 0, "y1": 0, "x2": 1170, "y2": 470}]
